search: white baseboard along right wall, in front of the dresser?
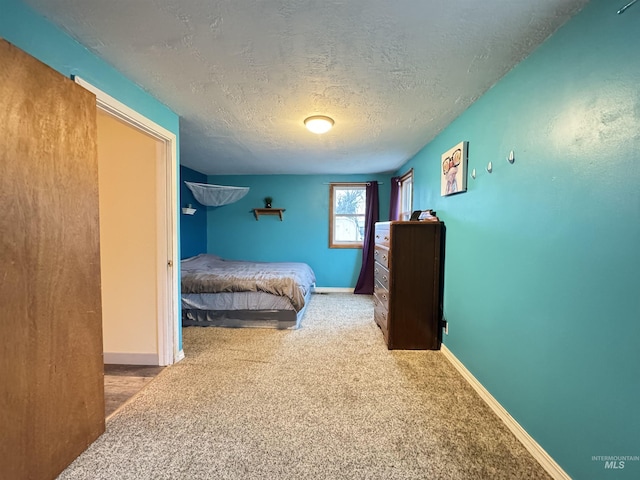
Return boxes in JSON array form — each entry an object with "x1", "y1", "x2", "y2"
[{"x1": 440, "y1": 344, "x2": 571, "y2": 480}]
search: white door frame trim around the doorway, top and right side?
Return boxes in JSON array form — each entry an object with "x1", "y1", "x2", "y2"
[{"x1": 72, "y1": 76, "x2": 184, "y2": 366}]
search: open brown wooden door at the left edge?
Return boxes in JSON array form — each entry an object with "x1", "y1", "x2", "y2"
[{"x1": 0, "y1": 40, "x2": 105, "y2": 480}]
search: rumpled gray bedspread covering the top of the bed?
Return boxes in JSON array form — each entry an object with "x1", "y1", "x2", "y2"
[{"x1": 181, "y1": 253, "x2": 316, "y2": 311}]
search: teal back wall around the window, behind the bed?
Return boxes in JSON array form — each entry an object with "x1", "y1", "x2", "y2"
[{"x1": 207, "y1": 175, "x2": 390, "y2": 288}]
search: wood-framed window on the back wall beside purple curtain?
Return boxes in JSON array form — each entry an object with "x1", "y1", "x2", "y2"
[{"x1": 329, "y1": 183, "x2": 367, "y2": 248}]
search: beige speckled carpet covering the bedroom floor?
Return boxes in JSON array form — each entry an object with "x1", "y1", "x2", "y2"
[{"x1": 59, "y1": 294, "x2": 549, "y2": 480}]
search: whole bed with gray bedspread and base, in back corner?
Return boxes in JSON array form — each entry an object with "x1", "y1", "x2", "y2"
[{"x1": 181, "y1": 253, "x2": 316, "y2": 329}]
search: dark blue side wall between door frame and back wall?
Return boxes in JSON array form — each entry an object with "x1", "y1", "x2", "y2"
[{"x1": 180, "y1": 166, "x2": 207, "y2": 259}]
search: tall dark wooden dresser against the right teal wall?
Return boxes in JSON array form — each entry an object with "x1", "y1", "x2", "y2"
[{"x1": 374, "y1": 221, "x2": 444, "y2": 350}]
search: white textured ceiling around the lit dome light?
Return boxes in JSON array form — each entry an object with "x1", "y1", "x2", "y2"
[{"x1": 25, "y1": 0, "x2": 587, "y2": 174}]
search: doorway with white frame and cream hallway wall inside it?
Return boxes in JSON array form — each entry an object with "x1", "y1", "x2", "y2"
[{"x1": 74, "y1": 77, "x2": 184, "y2": 366}]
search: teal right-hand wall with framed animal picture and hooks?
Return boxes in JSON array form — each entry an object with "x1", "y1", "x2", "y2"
[{"x1": 401, "y1": 0, "x2": 640, "y2": 479}]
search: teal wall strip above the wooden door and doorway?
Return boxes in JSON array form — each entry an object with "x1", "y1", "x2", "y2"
[{"x1": 0, "y1": 0, "x2": 182, "y2": 348}]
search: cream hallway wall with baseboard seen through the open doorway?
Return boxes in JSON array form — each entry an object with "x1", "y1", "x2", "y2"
[{"x1": 97, "y1": 109, "x2": 166, "y2": 365}]
